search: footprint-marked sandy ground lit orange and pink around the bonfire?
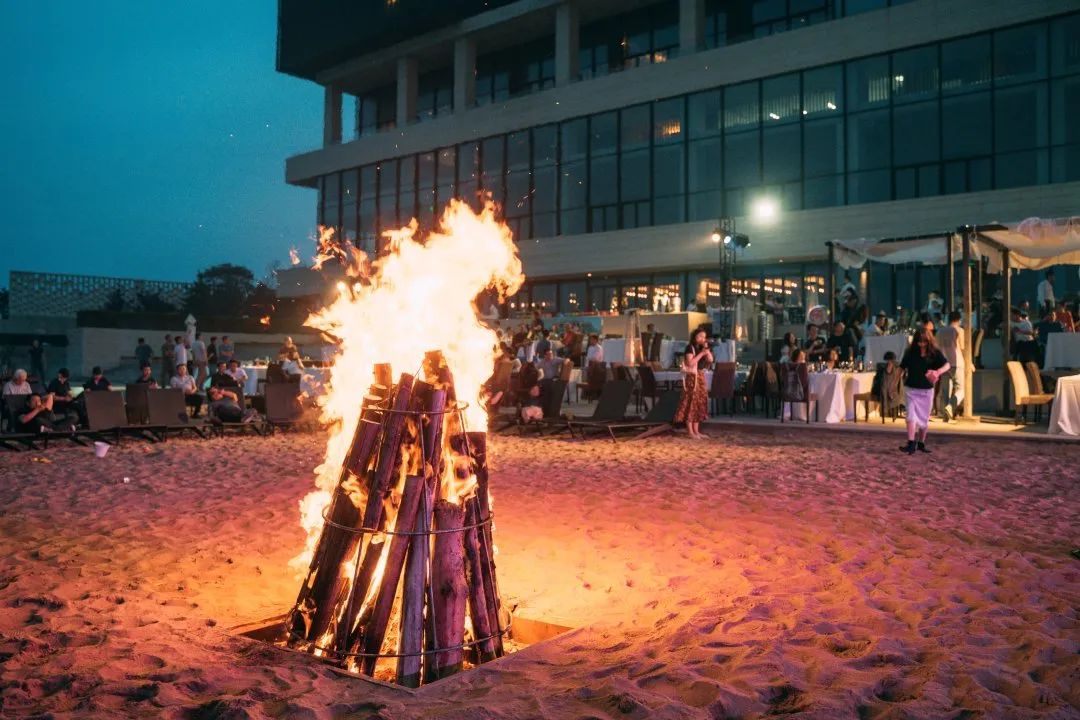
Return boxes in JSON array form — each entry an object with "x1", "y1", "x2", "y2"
[{"x1": 0, "y1": 431, "x2": 1080, "y2": 719}]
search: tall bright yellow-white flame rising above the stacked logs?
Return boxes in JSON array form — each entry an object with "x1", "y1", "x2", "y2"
[{"x1": 293, "y1": 201, "x2": 524, "y2": 568}]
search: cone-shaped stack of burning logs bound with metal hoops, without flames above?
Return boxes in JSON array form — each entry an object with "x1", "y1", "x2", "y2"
[{"x1": 286, "y1": 352, "x2": 507, "y2": 688}]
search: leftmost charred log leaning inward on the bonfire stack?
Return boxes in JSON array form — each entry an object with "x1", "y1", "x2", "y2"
[{"x1": 293, "y1": 388, "x2": 382, "y2": 642}]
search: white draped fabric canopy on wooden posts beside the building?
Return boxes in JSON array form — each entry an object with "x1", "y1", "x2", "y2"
[{"x1": 826, "y1": 216, "x2": 1080, "y2": 417}]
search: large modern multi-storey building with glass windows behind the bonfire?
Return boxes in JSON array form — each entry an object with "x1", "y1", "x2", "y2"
[{"x1": 278, "y1": 0, "x2": 1080, "y2": 312}]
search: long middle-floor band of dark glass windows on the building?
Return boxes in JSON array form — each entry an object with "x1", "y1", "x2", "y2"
[{"x1": 320, "y1": 12, "x2": 1080, "y2": 250}]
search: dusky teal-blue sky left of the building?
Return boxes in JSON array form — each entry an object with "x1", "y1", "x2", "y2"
[{"x1": 0, "y1": 0, "x2": 322, "y2": 287}]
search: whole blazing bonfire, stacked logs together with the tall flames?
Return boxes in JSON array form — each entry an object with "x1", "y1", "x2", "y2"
[{"x1": 286, "y1": 202, "x2": 523, "y2": 687}]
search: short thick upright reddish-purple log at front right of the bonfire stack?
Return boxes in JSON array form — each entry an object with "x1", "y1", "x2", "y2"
[{"x1": 430, "y1": 500, "x2": 468, "y2": 678}]
